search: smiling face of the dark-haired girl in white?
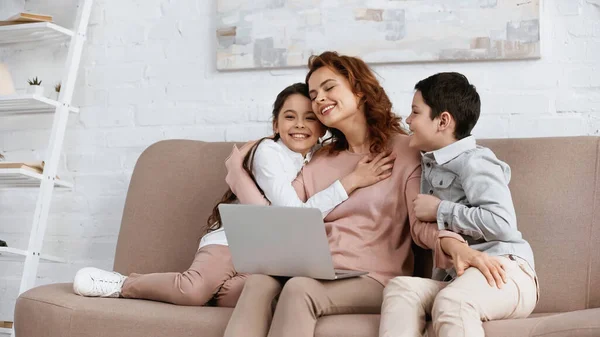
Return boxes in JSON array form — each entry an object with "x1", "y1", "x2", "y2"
[{"x1": 273, "y1": 94, "x2": 325, "y2": 155}]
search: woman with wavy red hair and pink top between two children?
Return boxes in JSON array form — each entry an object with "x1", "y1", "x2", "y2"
[{"x1": 220, "y1": 52, "x2": 462, "y2": 337}]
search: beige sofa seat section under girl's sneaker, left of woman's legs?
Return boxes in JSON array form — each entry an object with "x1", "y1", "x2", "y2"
[{"x1": 15, "y1": 283, "x2": 232, "y2": 337}]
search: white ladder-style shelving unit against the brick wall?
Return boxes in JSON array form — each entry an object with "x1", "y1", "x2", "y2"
[{"x1": 0, "y1": 0, "x2": 94, "y2": 337}]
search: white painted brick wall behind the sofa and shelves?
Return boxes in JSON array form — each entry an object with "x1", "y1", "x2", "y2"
[{"x1": 0, "y1": 0, "x2": 600, "y2": 320}]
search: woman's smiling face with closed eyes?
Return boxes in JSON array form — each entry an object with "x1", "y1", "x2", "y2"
[{"x1": 308, "y1": 67, "x2": 360, "y2": 128}]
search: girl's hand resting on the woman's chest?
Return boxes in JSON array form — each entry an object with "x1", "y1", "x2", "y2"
[{"x1": 340, "y1": 152, "x2": 396, "y2": 194}]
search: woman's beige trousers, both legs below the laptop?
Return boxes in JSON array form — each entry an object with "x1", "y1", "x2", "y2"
[{"x1": 225, "y1": 275, "x2": 383, "y2": 337}]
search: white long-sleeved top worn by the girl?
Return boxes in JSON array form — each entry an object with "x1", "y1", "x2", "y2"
[{"x1": 200, "y1": 139, "x2": 348, "y2": 247}]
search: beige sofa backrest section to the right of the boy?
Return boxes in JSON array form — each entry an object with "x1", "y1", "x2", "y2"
[{"x1": 479, "y1": 137, "x2": 600, "y2": 312}]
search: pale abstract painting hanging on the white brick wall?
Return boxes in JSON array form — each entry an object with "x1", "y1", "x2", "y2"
[{"x1": 216, "y1": 0, "x2": 540, "y2": 70}]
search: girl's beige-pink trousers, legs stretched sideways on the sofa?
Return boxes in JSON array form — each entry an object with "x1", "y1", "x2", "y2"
[{"x1": 121, "y1": 245, "x2": 247, "y2": 307}]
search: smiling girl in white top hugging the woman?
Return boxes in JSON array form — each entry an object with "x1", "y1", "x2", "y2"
[{"x1": 73, "y1": 83, "x2": 393, "y2": 307}]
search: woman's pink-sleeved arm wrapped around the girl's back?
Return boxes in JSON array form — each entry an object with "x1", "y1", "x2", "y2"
[{"x1": 225, "y1": 142, "x2": 269, "y2": 205}]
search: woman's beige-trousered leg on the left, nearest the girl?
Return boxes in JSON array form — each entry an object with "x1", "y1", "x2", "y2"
[{"x1": 225, "y1": 275, "x2": 283, "y2": 337}]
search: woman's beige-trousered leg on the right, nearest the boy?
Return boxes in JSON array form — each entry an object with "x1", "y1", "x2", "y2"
[{"x1": 269, "y1": 276, "x2": 383, "y2": 337}]
